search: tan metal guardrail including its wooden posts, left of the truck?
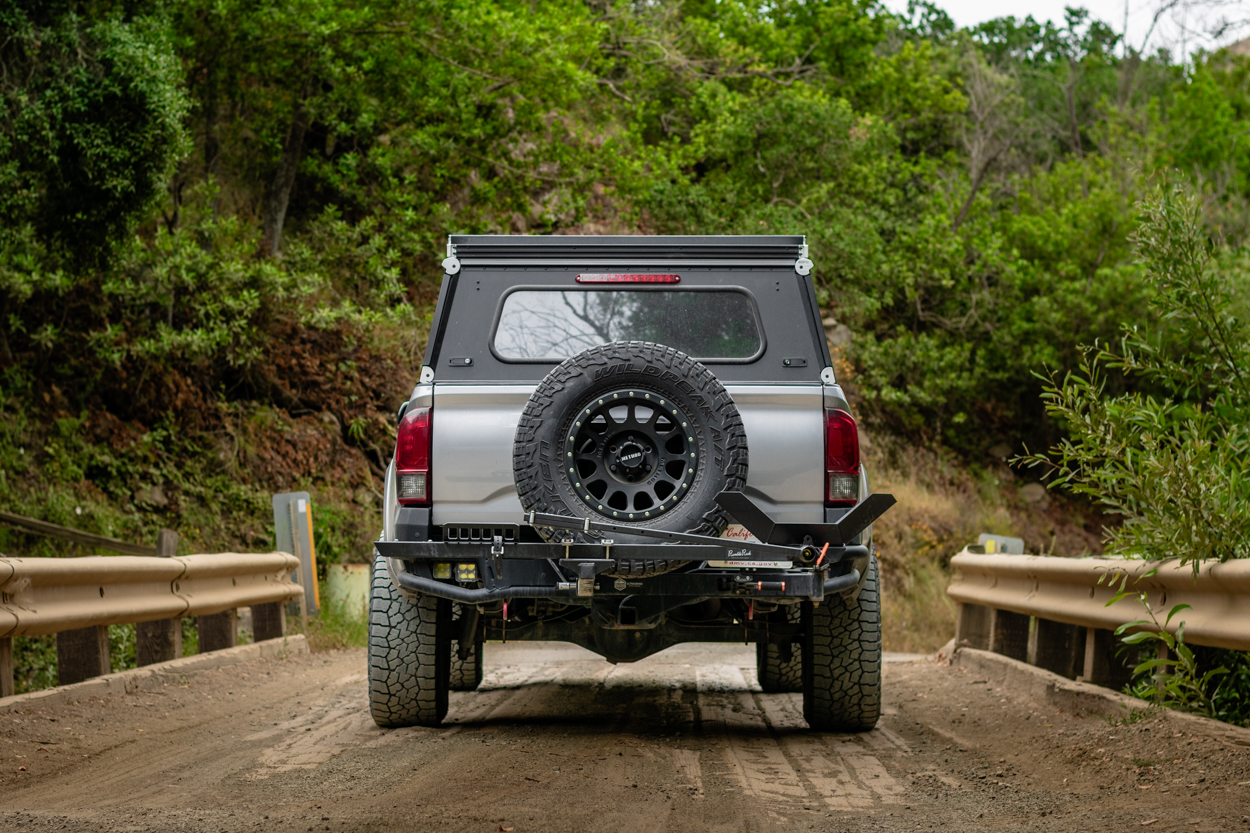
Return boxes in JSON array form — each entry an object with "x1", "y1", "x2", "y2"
[{"x1": 0, "y1": 553, "x2": 303, "y2": 697}]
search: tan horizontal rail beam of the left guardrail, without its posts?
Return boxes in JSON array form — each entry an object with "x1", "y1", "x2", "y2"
[{"x1": 0, "y1": 553, "x2": 301, "y2": 639}]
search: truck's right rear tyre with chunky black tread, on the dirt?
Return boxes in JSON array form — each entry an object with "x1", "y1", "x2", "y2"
[{"x1": 803, "y1": 555, "x2": 881, "y2": 732}]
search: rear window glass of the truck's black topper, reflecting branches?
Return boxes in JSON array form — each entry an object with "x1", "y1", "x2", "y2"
[{"x1": 491, "y1": 286, "x2": 764, "y2": 363}]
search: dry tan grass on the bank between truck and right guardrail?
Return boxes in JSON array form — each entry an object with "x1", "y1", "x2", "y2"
[{"x1": 865, "y1": 438, "x2": 1101, "y2": 653}]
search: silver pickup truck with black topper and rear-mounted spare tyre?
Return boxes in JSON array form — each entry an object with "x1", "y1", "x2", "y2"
[{"x1": 369, "y1": 235, "x2": 894, "y2": 732}]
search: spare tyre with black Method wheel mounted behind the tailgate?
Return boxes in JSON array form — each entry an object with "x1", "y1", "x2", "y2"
[{"x1": 513, "y1": 341, "x2": 746, "y2": 578}]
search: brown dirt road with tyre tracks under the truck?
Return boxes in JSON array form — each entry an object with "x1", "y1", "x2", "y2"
[{"x1": 0, "y1": 643, "x2": 1250, "y2": 833}]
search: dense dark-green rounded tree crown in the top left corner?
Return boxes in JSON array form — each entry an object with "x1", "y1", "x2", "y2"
[{"x1": 0, "y1": 0, "x2": 189, "y2": 263}]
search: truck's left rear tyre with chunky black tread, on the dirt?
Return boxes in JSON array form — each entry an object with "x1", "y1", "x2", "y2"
[{"x1": 369, "y1": 555, "x2": 451, "y2": 729}]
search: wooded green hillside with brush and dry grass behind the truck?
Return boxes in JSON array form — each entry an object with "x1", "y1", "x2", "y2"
[{"x1": 0, "y1": 0, "x2": 1250, "y2": 649}]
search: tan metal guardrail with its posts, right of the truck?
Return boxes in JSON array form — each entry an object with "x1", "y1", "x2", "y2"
[{"x1": 948, "y1": 549, "x2": 1250, "y2": 688}]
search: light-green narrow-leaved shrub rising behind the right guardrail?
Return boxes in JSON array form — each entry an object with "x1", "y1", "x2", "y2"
[{"x1": 1018, "y1": 189, "x2": 1250, "y2": 570}]
